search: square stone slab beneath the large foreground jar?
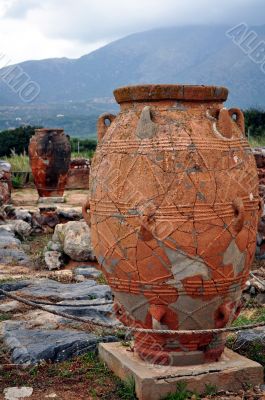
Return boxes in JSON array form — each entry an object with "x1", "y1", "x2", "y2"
[{"x1": 99, "y1": 343, "x2": 263, "y2": 400}]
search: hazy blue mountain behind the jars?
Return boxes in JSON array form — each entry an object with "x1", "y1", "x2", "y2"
[{"x1": 0, "y1": 25, "x2": 265, "y2": 136}]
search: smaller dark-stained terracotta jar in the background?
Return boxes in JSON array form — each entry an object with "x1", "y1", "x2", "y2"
[{"x1": 29, "y1": 129, "x2": 71, "y2": 197}]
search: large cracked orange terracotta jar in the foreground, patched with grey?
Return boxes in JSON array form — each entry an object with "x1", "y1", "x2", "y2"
[{"x1": 84, "y1": 85, "x2": 261, "y2": 365}]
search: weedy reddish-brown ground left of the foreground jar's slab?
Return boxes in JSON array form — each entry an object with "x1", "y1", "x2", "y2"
[{"x1": 0, "y1": 350, "x2": 136, "y2": 400}]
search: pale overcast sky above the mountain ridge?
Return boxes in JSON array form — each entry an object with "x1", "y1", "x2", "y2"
[{"x1": 0, "y1": 0, "x2": 265, "y2": 62}]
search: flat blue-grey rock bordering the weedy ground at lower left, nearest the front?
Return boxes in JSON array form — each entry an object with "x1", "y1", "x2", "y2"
[{"x1": 3, "y1": 321, "x2": 117, "y2": 365}]
